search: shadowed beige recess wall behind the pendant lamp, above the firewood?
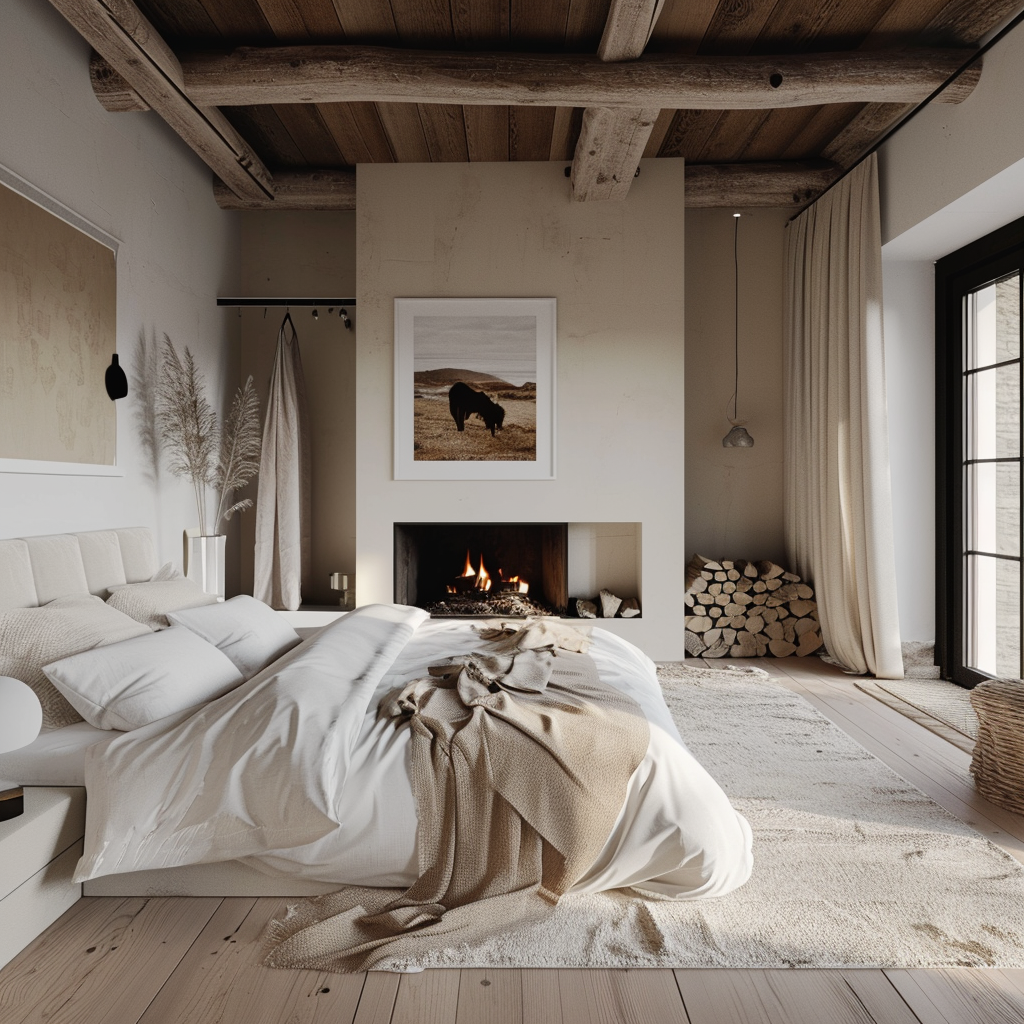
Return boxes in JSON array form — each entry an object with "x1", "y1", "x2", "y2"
[{"x1": 686, "y1": 209, "x2": 792, "y2": 563}]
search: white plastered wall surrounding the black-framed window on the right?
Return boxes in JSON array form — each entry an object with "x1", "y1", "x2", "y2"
[{"x1": 879, "y1": 18, "x2": 1024, "y2": 641}]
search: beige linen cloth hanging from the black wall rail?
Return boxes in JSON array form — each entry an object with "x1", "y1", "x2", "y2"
[{"x1": 253, "y1": 313, "x2": 310, "y2": 610}]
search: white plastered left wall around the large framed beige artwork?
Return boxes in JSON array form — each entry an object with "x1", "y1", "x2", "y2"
[{"x1": 0, "y1": 0, "x2": 239, "y2": 589}]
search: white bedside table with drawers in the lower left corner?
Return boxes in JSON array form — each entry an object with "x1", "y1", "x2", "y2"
[{"x1": 0, "y1": 785, "x2": 85, "y2": 967}]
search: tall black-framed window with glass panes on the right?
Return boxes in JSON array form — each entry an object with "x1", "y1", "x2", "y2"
[{"x1": 936, "y1": 219, "x2": 1024, "y2": 686}]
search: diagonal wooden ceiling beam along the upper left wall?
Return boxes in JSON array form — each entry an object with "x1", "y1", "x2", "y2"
[{"x1": 50, "y1": 0, "x2": 273, "y2": 199}]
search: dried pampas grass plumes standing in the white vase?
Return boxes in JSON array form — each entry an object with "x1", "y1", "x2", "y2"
[{"x1": 156, "y1": 334, "x2": 260, "y2": 536}]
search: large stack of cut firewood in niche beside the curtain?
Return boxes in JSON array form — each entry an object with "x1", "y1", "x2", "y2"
[{"x1": 686, "y1": 555, "x2": 821, "y2": 657}]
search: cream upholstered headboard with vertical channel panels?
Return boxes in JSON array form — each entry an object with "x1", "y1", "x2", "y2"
[{"x1": 0, "y1": 526, "x2": 159, "y2": 611}]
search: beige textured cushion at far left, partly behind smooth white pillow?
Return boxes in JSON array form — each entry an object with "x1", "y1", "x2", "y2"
[{"x1": 0, "y1": 594, "x2": 150, "y2": 728}]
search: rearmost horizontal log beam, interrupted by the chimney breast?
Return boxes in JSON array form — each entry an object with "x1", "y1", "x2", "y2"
[{"x1": 213, "y1": 160, "x2": 841, "y2": 210}]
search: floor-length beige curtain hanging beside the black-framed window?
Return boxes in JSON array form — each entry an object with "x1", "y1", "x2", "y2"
[{"x1": 785, "y1": 155, "x2": 903, "y2": 679}]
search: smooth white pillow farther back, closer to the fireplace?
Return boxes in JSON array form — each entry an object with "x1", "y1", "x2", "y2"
[{"x1": 167, "y1": 594, "x2": 302, "y2": 679}]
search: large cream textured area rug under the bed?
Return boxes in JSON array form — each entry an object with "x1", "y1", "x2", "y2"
[{"x1": 354, "y1": 665, "x2": 1024, "y2": 971}]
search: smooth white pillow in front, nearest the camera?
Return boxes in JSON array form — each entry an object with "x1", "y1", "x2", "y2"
[{"x1": 43, "y1": 629, "x2": 243, "y2": 731}]
